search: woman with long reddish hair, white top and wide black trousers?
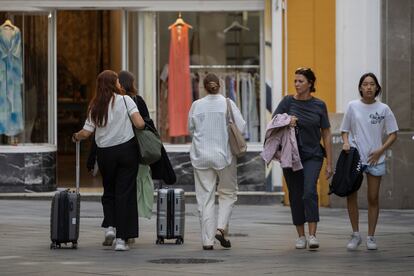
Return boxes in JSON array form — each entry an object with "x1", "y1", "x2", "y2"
[{"x1": 72, "y1": 70, "x2": 145, "y2": 251}]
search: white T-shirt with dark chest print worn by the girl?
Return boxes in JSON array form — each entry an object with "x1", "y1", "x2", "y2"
[{"x1": 341, "y1": 100, "x2": 398, "y2": 165}]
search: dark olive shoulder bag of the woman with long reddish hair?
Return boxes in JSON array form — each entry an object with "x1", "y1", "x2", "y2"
[{"x1": 123, "y1": 98, "x2": 162, "y2": 165}]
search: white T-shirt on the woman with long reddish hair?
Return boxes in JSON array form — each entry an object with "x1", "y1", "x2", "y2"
[{"x1": 83, "y1": 94, "x2": 139, "y2": 148}]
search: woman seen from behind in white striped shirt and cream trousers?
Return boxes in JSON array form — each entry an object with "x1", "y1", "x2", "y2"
[{"x1": 188, "y1": 74, "x2": 246, "y2": 250}]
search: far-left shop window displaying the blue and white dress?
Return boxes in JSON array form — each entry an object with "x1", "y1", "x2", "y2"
[{"x1": 0, "y1": 12, "x2": 48, "y2": 145}]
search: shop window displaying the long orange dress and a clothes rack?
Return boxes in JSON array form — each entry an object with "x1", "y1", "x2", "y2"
[{"x1": 157, "y1": 12, "x2": 261, "y2": 144}]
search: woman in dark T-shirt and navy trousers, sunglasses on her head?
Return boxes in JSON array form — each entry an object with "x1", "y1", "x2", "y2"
[{"x1": 273, "y1": 68, "x2": 332, "y2": 249}]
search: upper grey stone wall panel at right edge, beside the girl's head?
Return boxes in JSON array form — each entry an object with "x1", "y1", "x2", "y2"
[{"x1": 381, "y1": 0, "x2": 414, "y2": 129}]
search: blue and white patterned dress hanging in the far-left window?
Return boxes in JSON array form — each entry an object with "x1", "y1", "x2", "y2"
[{"x1": 0, "y1": 25, "x2": 23, "y2": 136}]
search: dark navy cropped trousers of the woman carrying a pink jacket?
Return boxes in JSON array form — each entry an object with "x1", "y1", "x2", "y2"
[{"x1": 283, "y1": 158, "x2": 323, "y2": 225}]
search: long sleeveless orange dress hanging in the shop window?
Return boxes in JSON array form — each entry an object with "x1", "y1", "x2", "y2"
[{"x1": 168, "y1": 24, "x2": 192, "y2": 137}]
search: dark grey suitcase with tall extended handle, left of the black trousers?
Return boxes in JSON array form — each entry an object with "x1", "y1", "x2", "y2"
[{"x1": 50, "y1": 142, "x2": 80, "y2": 249}]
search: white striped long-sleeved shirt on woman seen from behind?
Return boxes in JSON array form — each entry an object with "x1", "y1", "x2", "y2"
[{"x1": 188, "y1": 94, "x2": 246, "y2": 170}]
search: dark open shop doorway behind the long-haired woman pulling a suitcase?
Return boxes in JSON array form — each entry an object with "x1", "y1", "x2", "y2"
[{"x1": 56, "y1": 10, "x2": 122, "y2": 187}]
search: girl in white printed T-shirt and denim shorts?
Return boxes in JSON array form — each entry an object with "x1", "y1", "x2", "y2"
[{"x1": 341, "y1": 73, "x2": 398, "y2": 250}]
